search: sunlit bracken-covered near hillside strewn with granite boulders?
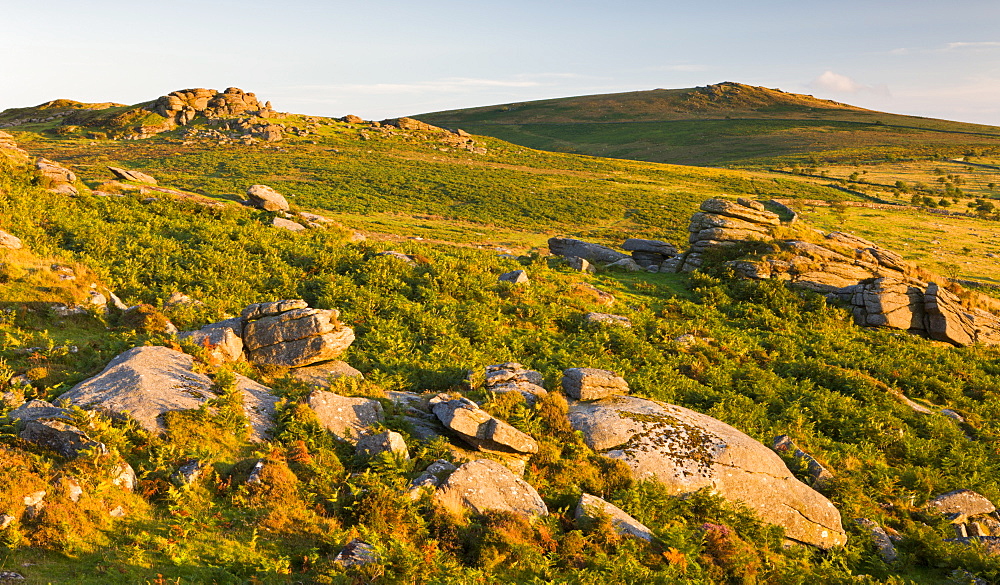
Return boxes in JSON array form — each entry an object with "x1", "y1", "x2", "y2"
[{"x1": 0, "y1": 88, "x2": 1000, "y2": 585}]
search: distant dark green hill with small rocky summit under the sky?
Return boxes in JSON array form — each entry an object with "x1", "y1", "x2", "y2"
[{"x1": 414, "y1": 82, "x2": 1000, "y2": 167}]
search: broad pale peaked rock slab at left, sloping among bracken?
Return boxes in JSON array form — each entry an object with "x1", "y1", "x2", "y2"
[{"x1": 59, "y1": 346, "x2": 215, "y2": 433}]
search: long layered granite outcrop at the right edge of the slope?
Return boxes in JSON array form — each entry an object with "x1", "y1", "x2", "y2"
[{"x1": 549, "y1": 199, "x2": 1000, "y2": 346}]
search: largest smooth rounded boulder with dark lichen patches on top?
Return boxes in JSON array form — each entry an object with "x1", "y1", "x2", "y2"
[{"x1": 569, "y1": 396, "x2": 847, "y2": 548}]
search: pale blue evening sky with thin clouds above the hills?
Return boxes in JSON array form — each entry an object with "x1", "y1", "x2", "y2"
[{"x1": 0, "y1": 0, "x2": 1000, "y2": 126}]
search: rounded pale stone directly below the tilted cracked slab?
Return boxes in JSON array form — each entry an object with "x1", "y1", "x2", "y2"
[{"x1": 433, "y1": 459, "x2": 549, "y2": 517}]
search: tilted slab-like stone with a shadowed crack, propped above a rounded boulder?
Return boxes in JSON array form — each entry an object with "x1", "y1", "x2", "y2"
[{"x1": 430, "y1": 394, "x2": 538, "y2": 455}]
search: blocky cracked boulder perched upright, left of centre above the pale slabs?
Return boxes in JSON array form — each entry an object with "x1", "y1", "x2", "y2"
[{"x1": 243, "y1": 303, "x2": 354, "y2": 367}]
